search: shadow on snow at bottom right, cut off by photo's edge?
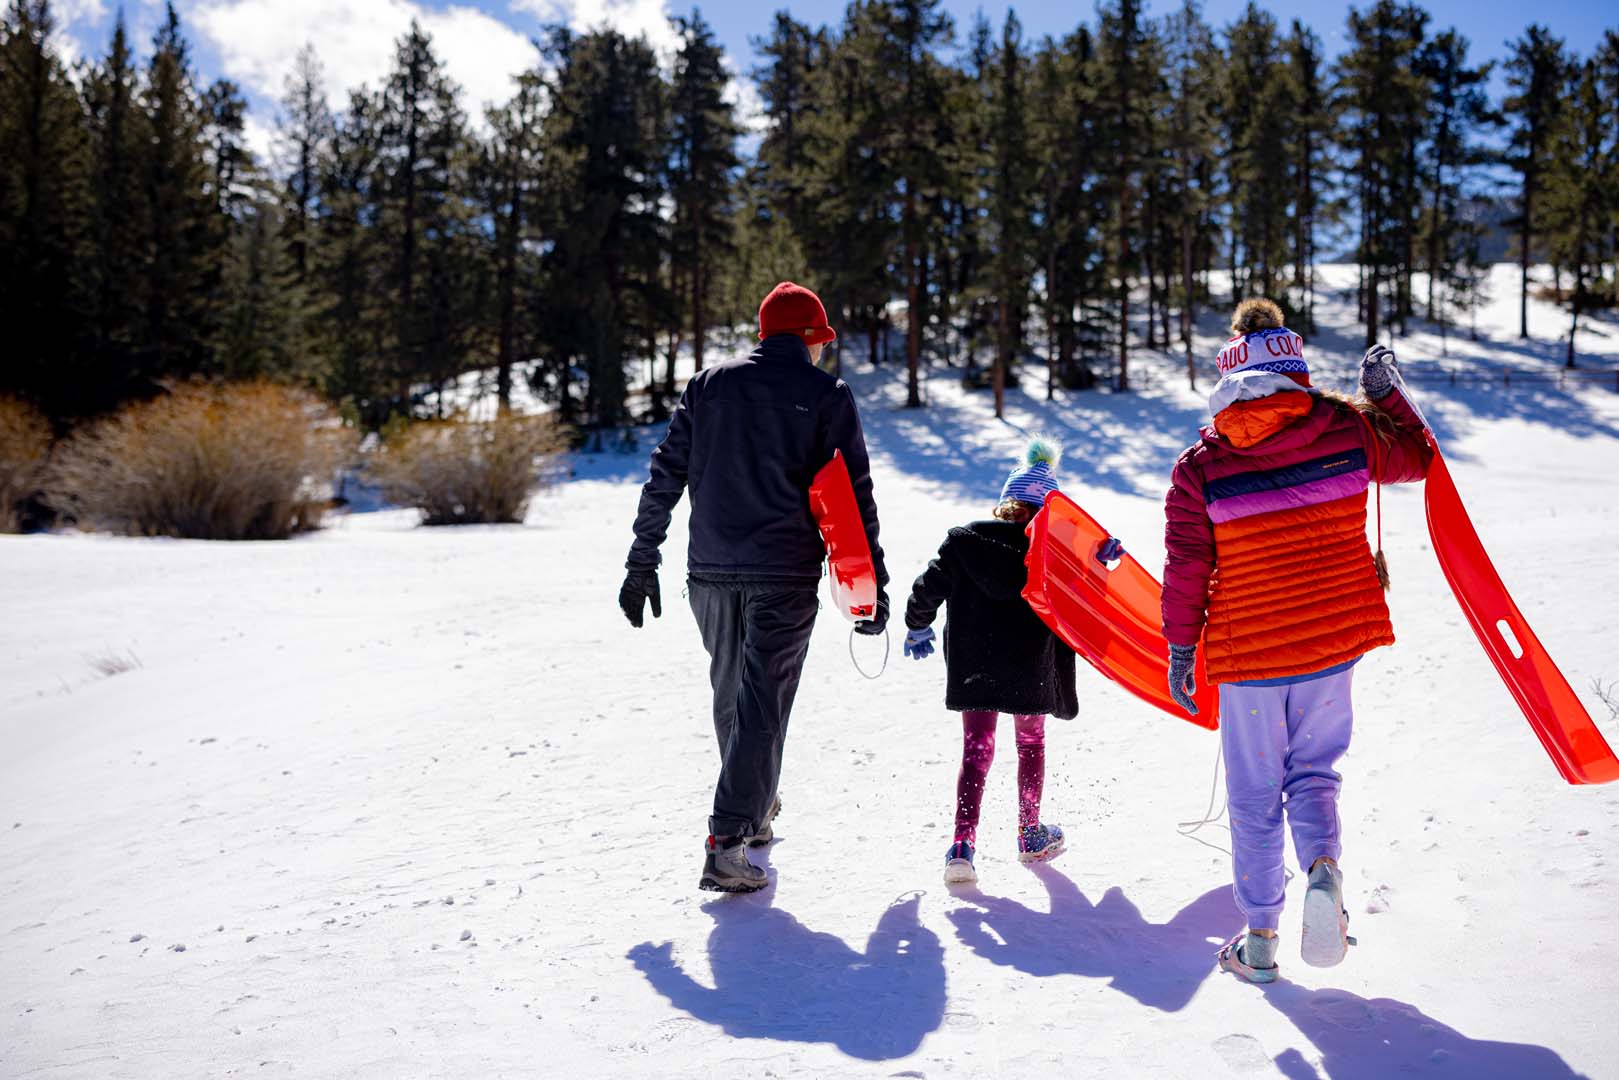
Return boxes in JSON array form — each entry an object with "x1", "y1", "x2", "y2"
[{"x1": 1263, "y1": 981, "x2": 1582, "y2": 1080}]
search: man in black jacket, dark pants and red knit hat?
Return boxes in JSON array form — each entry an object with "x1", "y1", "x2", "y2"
[{"x1": 618, "y1": 282, "x2": 889, "y2": 892}]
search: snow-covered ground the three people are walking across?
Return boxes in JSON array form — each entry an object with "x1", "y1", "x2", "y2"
[{"x1": 0, "y1": 263, "x2": 1619, "y2": 1080}]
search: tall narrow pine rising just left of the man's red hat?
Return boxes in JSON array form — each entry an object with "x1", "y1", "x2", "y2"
[{"x1": 669, "y1": 11, "x2": 742, "y2": 369}]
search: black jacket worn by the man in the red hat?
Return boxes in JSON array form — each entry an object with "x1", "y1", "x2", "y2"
[{"x1": 625, "y1": 334, "x2": 889, "y2": 585}]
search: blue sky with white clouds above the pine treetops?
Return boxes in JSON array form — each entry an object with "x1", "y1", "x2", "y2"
[{"x1": 55, "y1": 0, "x2": 1619, "y2": 158}]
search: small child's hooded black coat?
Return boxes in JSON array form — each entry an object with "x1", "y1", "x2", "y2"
[{"x1": 905, "y1": 521, "x2": 1080, "y2": 719}]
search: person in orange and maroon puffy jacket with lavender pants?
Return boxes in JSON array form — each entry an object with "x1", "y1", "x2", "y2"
[{"x1": 1162, "y1": 300, "x2": 1433, "y2": 983}]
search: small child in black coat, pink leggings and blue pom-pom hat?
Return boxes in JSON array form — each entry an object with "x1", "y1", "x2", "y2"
[{"x1": 905, "y1": 439, "x2": 1078, "y2": 882}]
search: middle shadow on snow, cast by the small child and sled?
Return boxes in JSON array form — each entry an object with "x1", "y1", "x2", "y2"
[{"x1": 950, "y1": 865, "x2": 1242, "y2": 1012}]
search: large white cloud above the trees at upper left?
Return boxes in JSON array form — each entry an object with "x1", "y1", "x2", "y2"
[{"x1": 191, "y1": 0, "x2": 536, "y2": 121}]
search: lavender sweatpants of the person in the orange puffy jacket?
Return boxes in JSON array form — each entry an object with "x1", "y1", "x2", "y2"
[{"x1": 1219, "y1": 669, "x2": 1355, "y2": 929}]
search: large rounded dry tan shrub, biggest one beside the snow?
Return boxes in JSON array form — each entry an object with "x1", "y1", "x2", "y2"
[{"x1": 49, "y1": 382, "x2": 353, "y2": 539}]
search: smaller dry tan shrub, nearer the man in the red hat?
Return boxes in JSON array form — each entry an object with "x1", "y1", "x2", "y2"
[{"x1": 369, "y1": 416, "x2": 567, "y2": 525}]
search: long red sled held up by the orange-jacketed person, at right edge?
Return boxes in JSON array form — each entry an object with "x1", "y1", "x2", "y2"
[{"x1": 1423, "y1": 434, "x2": 1619, "y2": 784}]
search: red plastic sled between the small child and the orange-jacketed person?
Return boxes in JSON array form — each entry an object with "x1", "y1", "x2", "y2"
[{"x1": 1023, "y1": 492, "x2": 1219, "y2": 730}]
